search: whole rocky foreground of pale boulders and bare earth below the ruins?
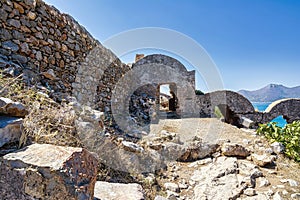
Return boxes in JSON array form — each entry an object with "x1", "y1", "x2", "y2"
[{"x1": 0, "y1": 94, "x2": 300, "y2": 200}]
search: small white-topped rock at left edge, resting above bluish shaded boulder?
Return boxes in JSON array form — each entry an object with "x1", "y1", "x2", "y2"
[{"x1": 0, "y1": 97, "x2": 28, "y2": 117}]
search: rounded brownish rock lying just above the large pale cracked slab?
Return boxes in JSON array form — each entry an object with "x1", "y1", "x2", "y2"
[{"x1": 221, "y1": 143, "x2": 250, "y2": 157}]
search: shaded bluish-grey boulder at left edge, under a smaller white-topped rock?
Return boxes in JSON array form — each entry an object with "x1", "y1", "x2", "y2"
[{"x1": 0, "y1": 116, "x2": 22, "y2": 147}]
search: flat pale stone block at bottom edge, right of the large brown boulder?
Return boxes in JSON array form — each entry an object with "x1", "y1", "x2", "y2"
[{"x1": 94, "y1": 181, "x2": 145, "y2": 200}]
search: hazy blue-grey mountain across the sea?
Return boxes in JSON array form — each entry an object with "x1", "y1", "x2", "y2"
[{"x1": 238, "y1": 84, "x2": 300, "y2": 102}]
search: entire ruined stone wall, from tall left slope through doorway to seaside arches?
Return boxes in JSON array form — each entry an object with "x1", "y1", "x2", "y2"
[{"x1": 0, "y1": 0, "x2": 300, "y2": 133}]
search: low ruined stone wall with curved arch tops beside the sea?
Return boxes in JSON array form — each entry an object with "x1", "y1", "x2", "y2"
[{"x1": 196, "y1": 91, "x2": 300, "y2": 128}]
